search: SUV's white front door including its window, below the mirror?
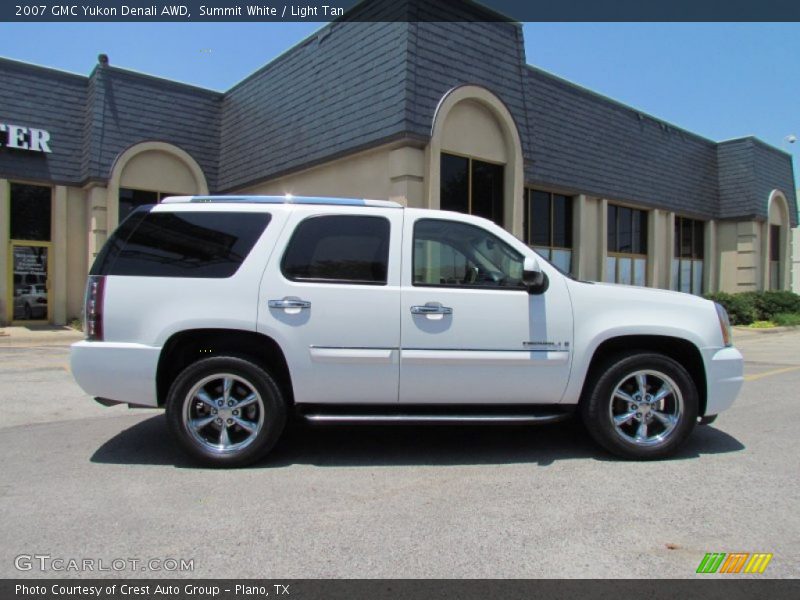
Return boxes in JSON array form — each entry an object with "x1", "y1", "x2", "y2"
[{"x1": 400, "y1": 211, "x2": 572, "y2": 404}]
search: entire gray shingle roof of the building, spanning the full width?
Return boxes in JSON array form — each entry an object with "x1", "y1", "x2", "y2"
[{"x1": 0, "y1": 0, "x2": 797, "y2": 224}]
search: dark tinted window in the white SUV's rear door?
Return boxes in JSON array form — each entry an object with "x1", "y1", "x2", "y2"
[{"x1": 281, "y1": 215, "x2": 390, "y2": 285}]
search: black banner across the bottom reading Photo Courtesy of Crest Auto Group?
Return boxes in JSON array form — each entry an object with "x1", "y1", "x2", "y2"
[{"x1": 0, "y1": 575, "x2": 800, "y2": 600}]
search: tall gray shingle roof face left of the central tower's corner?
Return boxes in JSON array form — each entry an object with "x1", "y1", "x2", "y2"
[{"x1": 218, "y1": 23, "x2": 408, "y2": 191}]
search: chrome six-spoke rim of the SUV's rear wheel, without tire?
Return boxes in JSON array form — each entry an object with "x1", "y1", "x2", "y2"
[{"x1": 182, "y1": 373, "x2": 264, "y2": 454}]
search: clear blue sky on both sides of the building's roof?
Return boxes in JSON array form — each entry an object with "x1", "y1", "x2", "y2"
[{"x1": 0, "y1": 23, "x2": 800, "y2": 181}]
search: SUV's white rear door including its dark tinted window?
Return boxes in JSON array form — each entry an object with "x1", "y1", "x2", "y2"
[{"x1": 258, "y1": 206, "x2": 403, "y2": 404}]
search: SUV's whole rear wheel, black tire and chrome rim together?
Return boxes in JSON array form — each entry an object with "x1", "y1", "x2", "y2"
[{"x1": 166, "y1": 356, "x2": 287, "y2": 467}]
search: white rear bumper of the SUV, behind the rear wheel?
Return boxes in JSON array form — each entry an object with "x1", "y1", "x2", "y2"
[{"x1": 70, "y1": 341, "x2": 161, "y2": 406}]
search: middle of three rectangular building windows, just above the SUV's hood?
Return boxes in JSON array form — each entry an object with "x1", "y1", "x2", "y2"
[{"x1": 606, "y1": 204, "x2": 647, "y2": 285}]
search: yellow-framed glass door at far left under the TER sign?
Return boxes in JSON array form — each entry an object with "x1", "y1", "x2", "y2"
[{"x1": 6, "y1": 241, "x2": 51, "y2": 323}]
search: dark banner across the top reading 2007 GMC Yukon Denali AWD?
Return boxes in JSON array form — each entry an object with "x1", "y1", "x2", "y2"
[{"x1": 0, "y1": 0, "x2": 800, "y2": 23}]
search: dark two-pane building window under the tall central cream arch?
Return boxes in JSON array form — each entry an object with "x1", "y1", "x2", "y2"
[{"x1": 439, "y1": 153, "x2": 503, "y2": 226}]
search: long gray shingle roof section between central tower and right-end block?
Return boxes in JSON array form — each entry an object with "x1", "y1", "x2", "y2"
[{"x1": 525, "y1": 67, "x2": 719, "y2": 218}]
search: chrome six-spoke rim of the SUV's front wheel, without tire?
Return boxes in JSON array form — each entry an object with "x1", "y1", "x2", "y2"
[{"x1": 608, "y1": 370, "x2": 684, "y2": 446}]
